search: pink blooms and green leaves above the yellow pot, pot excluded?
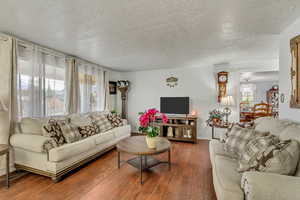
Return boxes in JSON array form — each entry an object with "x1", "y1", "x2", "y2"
[{"x1": 139, "y1": 108, "x2": 169, "y2": 137}]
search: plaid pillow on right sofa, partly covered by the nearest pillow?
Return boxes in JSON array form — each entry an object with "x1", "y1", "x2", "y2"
[{"x1": 238, "y1": 135, "x2": 279, "y2": 172}]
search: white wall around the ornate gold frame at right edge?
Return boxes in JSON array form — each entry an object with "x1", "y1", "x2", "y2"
[{"x1": 279, "y1": 18, "x2": 300, "y2": 121}]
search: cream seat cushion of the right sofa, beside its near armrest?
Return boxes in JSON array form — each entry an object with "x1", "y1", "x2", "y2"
[{"x1": 213, "y1": 155, "x2": 244, "y2": 200}]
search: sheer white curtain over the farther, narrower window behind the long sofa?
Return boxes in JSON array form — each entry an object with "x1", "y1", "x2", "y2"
[{"x1": 76, "y1": 59, "x2": 105, "y2": 113}]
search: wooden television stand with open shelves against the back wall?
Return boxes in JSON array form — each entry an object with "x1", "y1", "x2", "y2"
[{"x1": 154, "y1": 116, "x2": 198, "y2": 143}]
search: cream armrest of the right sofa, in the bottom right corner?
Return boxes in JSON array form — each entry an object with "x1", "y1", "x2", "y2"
[{"x1": 241, "y1": 172, "x2": 300, "y2": 200}]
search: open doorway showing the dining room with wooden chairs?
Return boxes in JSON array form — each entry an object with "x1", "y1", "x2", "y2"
[{"x1": 239, "y1": 71, "x2": 279, "y2": 122}]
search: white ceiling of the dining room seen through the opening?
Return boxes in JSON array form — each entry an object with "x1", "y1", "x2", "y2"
[{"x1": 240, "y1": 71, "x2": 279, "y2": 83}]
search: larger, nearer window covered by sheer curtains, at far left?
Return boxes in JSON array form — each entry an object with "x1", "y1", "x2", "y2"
[{"x1": 17, "y1": 42, "x2": 66, "y2": 118}]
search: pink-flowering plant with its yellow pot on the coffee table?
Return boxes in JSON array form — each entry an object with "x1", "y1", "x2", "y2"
[{"x1": 139, "y1": 108, "x2": 168, "y2": 148}]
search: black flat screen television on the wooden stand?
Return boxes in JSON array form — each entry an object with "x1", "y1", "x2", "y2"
[{"x1": 160, "y1": 97, "x2": 190, "y2": 115}]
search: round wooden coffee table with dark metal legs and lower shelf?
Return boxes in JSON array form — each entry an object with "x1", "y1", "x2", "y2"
[{"x1": 117, "y1": 136, "x2": 171, "y2": 184}]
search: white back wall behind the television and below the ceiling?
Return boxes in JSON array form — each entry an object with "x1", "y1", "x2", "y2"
[{"x1": 122, "y1": 67, "x2": 239, "y2": 138}]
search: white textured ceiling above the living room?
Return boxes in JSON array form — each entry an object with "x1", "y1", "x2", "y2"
[{"x1": 0, "y1": 0, "x2": 300, "y2": 71}]
